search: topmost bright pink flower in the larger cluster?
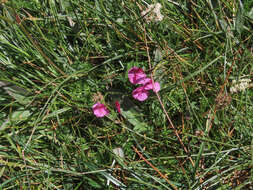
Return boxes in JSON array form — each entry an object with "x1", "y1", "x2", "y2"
[{"x1": 128, "y1": 67, "x2": 146, "y2": 84}]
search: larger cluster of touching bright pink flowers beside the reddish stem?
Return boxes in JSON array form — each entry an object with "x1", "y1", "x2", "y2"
[{"x1": 128, "y1": 67, "x2": 160, "y2": 101}]
